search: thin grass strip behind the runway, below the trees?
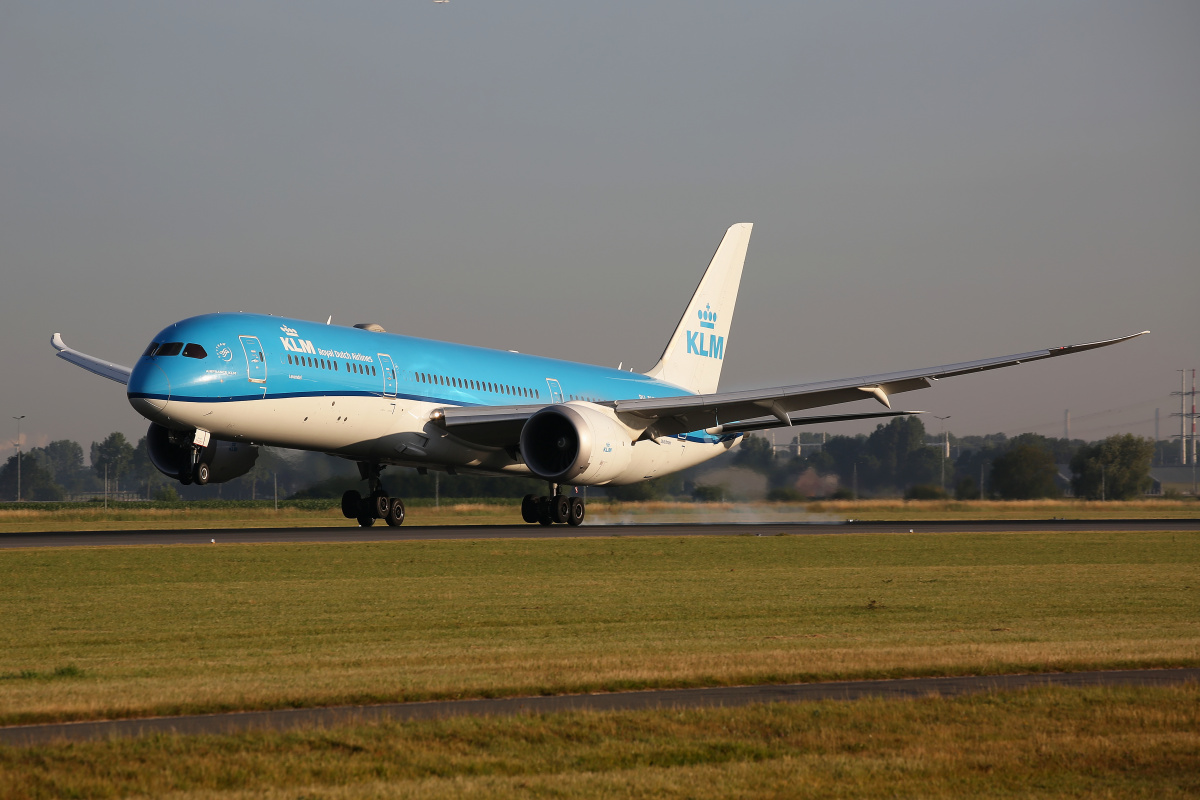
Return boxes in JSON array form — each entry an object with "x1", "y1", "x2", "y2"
[{"x1": 0, "y1": 498, "x2": 1200, "y2": 533}]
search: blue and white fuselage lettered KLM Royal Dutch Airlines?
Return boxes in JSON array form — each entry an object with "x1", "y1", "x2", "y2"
[{"x1": 127, "y1": 313, "x2": 740, "y2": 483}]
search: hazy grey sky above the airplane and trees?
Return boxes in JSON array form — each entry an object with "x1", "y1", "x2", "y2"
[{"x1": 0, "y1": 0, "x2": 1200, "y2": 456}]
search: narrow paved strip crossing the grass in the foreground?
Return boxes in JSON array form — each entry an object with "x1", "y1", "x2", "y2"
[{"x1": 0, "y1": 668, "x2": 1200, "y2": 746}]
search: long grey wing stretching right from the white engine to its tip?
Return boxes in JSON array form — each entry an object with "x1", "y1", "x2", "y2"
[{"x1": 616, "y1": 331, "x2": 1150, "y2": 427}]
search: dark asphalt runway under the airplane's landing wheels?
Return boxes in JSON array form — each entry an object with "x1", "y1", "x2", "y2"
[{"x1": 0, "y1": 519, "x2": 1200, "y2": 548}]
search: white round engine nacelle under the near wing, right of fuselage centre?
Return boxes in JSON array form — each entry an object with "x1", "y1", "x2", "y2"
[{"x1": 521, "y1": 403, "x2": 632, "y2": 486}]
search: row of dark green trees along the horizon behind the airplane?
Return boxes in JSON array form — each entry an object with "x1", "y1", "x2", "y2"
[{"x1": 0, "y1": 416, "x2": 1156, "y2": 500}]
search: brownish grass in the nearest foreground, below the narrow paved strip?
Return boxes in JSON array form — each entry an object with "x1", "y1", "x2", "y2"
[{"x1": 0, "y1": 685, "x2": 1200, "y2": 800}]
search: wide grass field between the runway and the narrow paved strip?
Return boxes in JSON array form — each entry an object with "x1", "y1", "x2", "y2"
[{"x1": 0, "y1": 531, "x2": 1200, "y2": 724}]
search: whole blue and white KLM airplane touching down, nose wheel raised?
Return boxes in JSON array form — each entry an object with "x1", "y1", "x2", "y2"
[{"x1": 52, "y1": 223, "x2": 1148, "y2": 527}]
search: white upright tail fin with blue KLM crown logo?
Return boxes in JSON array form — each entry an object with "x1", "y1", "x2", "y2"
[{"x1": 646, "y1": 222, "x2": 754, "y2": 395}]
